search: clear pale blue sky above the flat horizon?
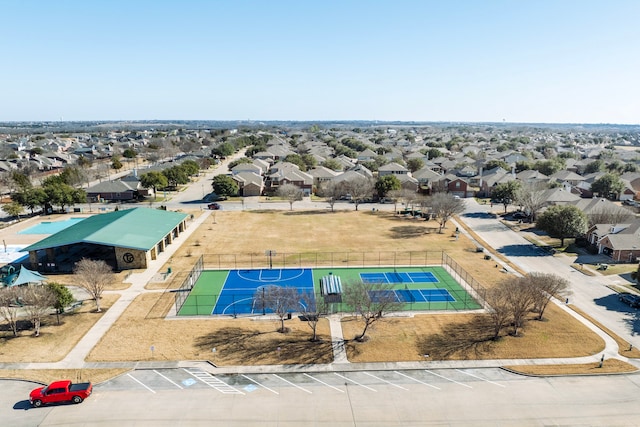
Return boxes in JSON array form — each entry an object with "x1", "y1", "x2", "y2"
[{"x1": 0, "y1": 0, "x2": 640, "y2": 124}]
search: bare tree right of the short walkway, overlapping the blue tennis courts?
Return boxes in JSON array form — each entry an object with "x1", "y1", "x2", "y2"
[{"x1": 342, "y1": 280, "x2": 402, "y2": 341}]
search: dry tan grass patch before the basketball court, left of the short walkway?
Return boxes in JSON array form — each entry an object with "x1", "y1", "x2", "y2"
[{"x1": 88, "y1": 293, "x2": 333, "y2": 365}]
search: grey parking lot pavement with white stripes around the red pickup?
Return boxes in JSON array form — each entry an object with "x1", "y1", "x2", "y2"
[{"x1": 5, "y1": 368, "x2": 640, "y2": 427}]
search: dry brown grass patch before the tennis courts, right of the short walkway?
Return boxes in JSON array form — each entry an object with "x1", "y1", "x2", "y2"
[{"x1": 342, "y1": 305, "x2": 604, "y2": 362}]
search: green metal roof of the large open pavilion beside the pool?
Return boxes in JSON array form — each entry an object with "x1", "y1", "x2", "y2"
[{"x1": 23, "y1": 208, "x2": 188, "y2": 251}]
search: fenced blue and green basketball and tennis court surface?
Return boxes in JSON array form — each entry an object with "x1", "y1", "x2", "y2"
[{"x1": 178, "y1": 266, "x2": 482, "y2": 316}]
